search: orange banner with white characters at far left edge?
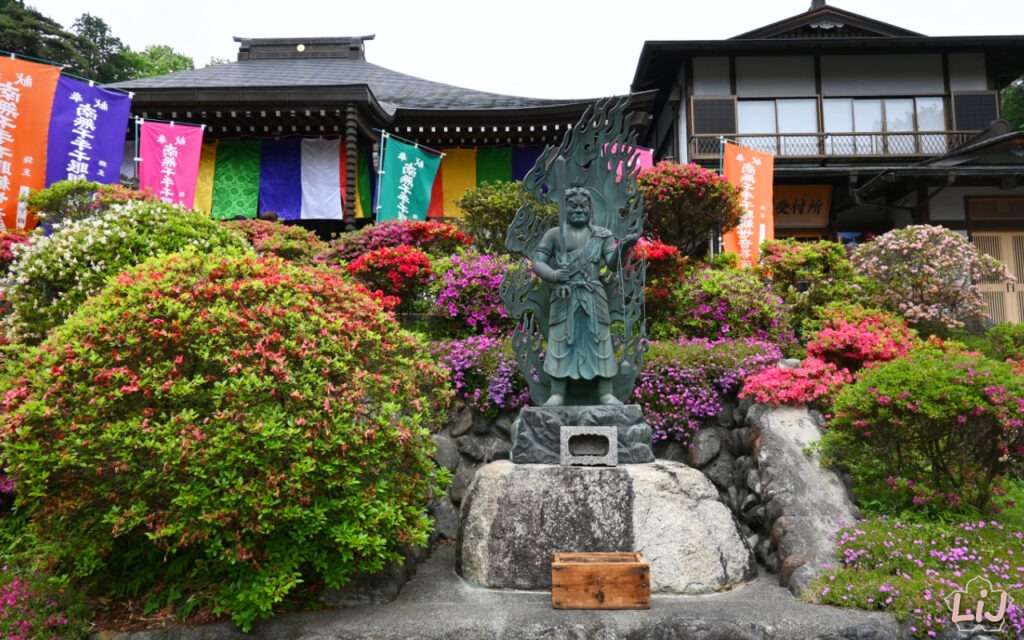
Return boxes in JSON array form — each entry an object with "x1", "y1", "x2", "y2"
[{"x1": 0, "y1": 57, "x2": 60, "y2": 229}]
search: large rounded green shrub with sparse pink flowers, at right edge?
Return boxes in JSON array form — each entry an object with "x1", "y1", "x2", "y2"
[{"x1": 821, "y1": 340, "x2": 1024, "y2": 513}]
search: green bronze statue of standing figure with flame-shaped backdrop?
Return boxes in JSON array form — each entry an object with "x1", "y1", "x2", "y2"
[{"x1": 501, "y1": 99, "x2": 646, "y2": 407}]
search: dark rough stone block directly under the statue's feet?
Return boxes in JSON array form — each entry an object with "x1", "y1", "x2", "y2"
[{"x1": 512, "y1": 404, "x2": 654, "y2": 465}]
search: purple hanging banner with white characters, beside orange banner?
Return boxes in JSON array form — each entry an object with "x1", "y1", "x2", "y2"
[{"x1": 46, "y1": 76, "x2": 131, "y2": 186}]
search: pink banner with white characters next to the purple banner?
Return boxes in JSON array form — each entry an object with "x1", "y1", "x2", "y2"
[{"x1": 138, "y1": 121, "x2": 203, "y2": 209}]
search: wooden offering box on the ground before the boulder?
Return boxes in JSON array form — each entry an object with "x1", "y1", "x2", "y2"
[{"x1": 551, "y1": 552, "x2": 650, "y2": 609}]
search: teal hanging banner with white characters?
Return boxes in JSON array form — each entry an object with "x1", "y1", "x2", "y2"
[{"x1": 377, "y1": 134, "x2": 441, "y2": 222}]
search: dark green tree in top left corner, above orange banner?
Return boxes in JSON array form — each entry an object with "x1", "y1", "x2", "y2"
[{"x1": 0, "y1": 0, "x2": 88, "y2": 73}]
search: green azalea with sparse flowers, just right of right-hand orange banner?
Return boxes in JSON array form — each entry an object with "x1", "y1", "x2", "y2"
[{"x1": 758, "y1": 238, "x2": 870, "y2": 338}]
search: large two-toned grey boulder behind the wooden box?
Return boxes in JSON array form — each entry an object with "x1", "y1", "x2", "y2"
[{"x1": 456, "y1": 461, "x2": 755, "y2": 594}]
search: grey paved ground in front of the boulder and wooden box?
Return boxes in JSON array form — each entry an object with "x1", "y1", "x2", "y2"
[{"x1": 90, "y1": 546, "x2": 899, "y2": 640}]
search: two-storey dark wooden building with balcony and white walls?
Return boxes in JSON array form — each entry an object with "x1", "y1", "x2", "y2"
[{"x1": 632, "y1": 0, "x2": 1024, "y2": 322}]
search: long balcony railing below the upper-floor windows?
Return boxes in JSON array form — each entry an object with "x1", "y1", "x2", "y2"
[{"x1": 689, "y1": 131, "x2": 978, "y2": 160}]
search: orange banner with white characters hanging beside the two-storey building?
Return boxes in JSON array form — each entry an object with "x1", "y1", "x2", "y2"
[{"x1": 722, "y1": 142, "x2": 775, "y2": 266}]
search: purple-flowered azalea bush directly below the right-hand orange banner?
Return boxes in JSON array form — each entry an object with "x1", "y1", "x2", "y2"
[{"x1": 651, "y1": 268, "x2": 796, "y2": 351}]
